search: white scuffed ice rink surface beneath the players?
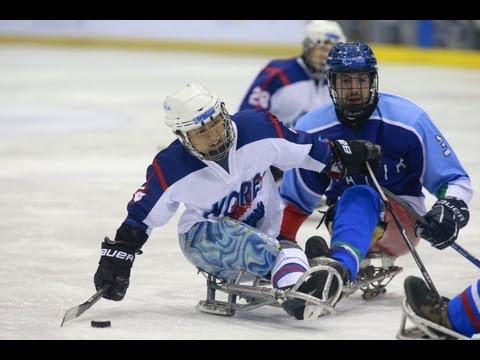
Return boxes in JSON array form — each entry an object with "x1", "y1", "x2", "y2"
[{"x1": 0, "y1": 46, "x2": 480, "y2": 340}]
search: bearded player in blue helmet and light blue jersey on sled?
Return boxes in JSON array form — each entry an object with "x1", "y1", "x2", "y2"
[{"x1": 279, "y1": 42, "x2": 473, "y2": 290}]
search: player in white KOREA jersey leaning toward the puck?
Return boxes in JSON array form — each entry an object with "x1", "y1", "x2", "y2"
[{"x1": 94, "y1": 84, "x2": 381, "y2": 319}]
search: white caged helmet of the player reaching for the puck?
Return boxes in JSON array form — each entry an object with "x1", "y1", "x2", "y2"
[{"x1": 163, "y1": 83, "x2": 234, "y2": 161}]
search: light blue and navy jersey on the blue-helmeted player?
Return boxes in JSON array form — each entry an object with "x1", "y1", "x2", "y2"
[{"x1": 280, "y1": 93, "x2": 473, "y2": 214}]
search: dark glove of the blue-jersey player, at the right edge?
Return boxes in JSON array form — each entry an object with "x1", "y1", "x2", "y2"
[{"x1": 415, "y1": 197, "x2": 470, "y2": 249}]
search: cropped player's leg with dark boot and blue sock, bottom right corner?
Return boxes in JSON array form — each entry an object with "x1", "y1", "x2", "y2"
[{"x1": 404, "y1": 276, "x2": 480, "y2": 338}]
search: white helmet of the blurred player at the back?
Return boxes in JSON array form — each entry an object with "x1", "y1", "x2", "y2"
[{"x1": 302, "y1": 20, "x2": 346, "y2": 80}]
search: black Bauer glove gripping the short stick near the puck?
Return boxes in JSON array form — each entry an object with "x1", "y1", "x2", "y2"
[{"x1": 93, "y1": 237, "x2": 135, "y2": 301}]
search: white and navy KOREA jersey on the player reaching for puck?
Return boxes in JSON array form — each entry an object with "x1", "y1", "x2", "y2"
[{"x1": 124, "y1": 110, "x2": 331, "y2": 237}]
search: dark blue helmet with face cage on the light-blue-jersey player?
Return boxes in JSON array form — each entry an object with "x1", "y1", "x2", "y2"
[{"x1": 326, "y1": 41, "x2": 378, "y2": 129}]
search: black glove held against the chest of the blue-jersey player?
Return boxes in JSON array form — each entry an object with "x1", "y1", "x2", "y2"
[{"x1": 326, "y1": 140, "x2": 383, "y2": 180}]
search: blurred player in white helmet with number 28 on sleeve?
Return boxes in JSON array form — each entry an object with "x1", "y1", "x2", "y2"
[{"x1": 239, "y1": 20, "x2": 346, "y2": 181}]
